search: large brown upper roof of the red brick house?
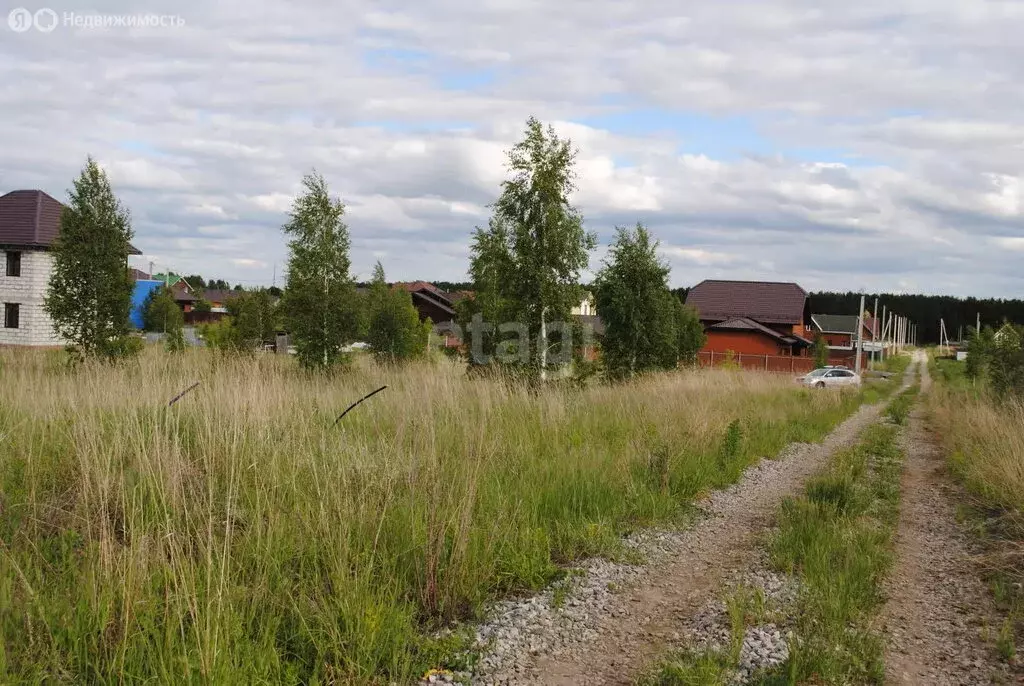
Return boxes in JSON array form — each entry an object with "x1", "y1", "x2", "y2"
[{"x1": 686, "y1": 280, "x2": 807, "y2": 324}]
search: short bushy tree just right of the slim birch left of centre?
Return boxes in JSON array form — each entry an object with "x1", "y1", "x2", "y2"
[{"x1": 367, "y1": 262, "x2": 430, "y2": 363}]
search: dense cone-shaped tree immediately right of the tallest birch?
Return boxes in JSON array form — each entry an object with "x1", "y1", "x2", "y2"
[{"x1": 594, "y1": 224, "x2": 680, "y2": 378}]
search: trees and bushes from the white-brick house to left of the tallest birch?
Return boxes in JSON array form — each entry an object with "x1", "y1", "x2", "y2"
[{"x1": 44, "y1": 158, "x2": 429, "y2": 367}]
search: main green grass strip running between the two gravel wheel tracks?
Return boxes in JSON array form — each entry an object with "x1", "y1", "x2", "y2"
[{"x1": 770, "y1": 423, "x2": 905, "y2": 684}]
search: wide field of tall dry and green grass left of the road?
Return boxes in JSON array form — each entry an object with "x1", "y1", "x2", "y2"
[{"x1": 0, "y1": 350, "x2": 860, "y2": 683}]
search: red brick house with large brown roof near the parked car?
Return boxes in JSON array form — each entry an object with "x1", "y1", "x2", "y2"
[{"x1": 686, "y1": 280, "x2": 813, "y2": 357}]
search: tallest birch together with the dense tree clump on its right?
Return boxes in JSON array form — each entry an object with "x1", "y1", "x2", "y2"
[{"x1": 459, "y1": 118, "x2": 703, "y2": 381}]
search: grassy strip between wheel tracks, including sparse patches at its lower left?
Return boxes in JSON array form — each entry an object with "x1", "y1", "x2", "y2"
[{"x1": 650, "y1": 389, "x2": 915, "y2": 686}]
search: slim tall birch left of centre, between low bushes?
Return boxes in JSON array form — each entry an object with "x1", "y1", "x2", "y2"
[{"x1": 283, "y1": 171, "x2": 359, "y2": 369}]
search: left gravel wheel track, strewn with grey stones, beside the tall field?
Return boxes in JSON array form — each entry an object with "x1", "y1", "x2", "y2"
[{"x1": 448, "y1": 369, "x2": 912, "y2": 685}]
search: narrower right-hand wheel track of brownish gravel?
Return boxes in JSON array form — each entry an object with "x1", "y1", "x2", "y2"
[{"x1": 883, "y1": 353, "x2": 1010, "y2": 686}]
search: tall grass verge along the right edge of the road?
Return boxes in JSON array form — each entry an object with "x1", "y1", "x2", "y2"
[{"x1": 928, "y1": 359, "x2": 1024, "y2": 659}]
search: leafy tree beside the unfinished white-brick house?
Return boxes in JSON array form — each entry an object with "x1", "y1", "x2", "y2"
[{"x1": 43, "y1": 157, "x2": 134, "y2": 358}]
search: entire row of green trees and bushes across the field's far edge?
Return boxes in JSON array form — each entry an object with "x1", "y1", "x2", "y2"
[{"x1": 46, "y1": 118, "x2": 703, "y2": 380}]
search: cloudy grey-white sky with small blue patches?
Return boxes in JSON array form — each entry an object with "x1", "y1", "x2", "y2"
[{"x1": 0, "y1": 0, "x2": 1024, "y2": 297}]
